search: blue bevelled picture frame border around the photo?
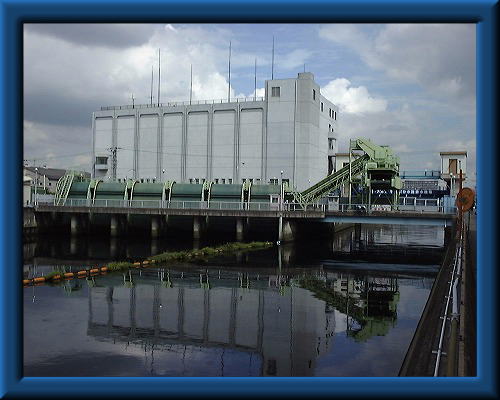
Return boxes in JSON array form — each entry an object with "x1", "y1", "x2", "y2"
[{"x1": 0, "y1": 0, "x2": 492, "y2": 398}]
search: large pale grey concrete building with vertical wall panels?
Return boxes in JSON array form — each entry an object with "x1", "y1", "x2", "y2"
[{"x1": 92, "y1": 72, "x2": 338, "y2": 190}]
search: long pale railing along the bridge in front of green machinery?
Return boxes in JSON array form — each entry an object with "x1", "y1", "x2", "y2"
[{"x1": 38, "y1": 199, "x2": 456, "y2": 214}]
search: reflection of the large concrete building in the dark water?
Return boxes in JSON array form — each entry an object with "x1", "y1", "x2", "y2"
[{"x1": 88, "y1": 276, "x2": 335, "y2": 376}]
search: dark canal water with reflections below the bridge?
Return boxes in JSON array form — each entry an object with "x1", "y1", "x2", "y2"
[{"x1": 23, "y1": 225, "x2": 444, "y2": 377}]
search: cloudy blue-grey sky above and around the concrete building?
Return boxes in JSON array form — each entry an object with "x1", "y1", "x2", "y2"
[{"x1": 24, "y1": 24, "x2": 476, "y2": 184}]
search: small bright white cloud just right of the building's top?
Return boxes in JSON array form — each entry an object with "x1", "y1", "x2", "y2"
[{"x1": 321, "y1": 78, "x2": 387, "y2": 114}]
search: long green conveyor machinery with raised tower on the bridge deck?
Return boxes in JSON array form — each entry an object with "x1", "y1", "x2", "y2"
[{"x1": 54, "y1": 138, "x2": 402, "y2": 209}]
